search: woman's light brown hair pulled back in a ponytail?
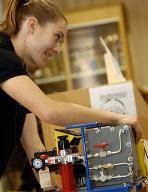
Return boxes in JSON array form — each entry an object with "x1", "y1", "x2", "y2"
[{"x1": 0, "y1": 0, "x2": 67, "y2": 37}]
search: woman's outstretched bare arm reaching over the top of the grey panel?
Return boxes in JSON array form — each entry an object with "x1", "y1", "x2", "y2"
[{"x1": 1, "y1": 75, "x2": 142, "y2": 138}]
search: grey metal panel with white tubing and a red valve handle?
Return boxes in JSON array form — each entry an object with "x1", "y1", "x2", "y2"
[{"x1": 86, "y1": 125, "x2": 141, "y2": 188}]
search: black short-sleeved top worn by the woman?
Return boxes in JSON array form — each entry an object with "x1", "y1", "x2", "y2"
[{"x1": 0, "y1": 32, "x2": 27, "y2": 178}]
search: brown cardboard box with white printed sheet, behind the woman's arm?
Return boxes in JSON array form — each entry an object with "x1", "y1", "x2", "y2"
[{"x1": 42, "y1": 81, "x2": 148, "y2": 149}]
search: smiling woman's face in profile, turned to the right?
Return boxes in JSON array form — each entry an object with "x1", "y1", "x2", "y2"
[{"x1": 25, "y1": 20, "x2": 67, "y2": 68}]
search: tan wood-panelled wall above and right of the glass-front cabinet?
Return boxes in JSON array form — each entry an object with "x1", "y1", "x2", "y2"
[{"x1": 0, "y1": 0, "x2": 148, "y2": 85}]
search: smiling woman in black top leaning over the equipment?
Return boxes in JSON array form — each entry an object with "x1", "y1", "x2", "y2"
[{"x1": 0, "y1": 0, "x2": 142, "y2": 186}]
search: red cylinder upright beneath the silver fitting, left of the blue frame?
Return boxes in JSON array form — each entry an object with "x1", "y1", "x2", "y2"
[{"x1": 60, "y1": 163, "x2": 76, "y2": 192}]
